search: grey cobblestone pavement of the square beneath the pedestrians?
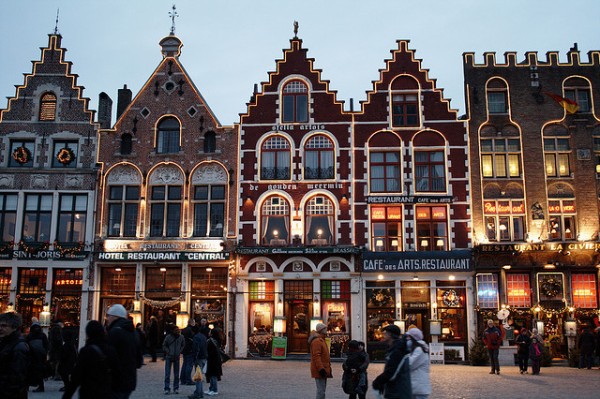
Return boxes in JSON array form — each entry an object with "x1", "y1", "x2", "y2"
[{"x1": 29, "y1": 359, "x2": 600, "y2": 399}]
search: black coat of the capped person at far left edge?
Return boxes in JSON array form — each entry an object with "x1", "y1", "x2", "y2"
[{"x1": 0, "y1": 330, "x2": 29, "y2": 399}]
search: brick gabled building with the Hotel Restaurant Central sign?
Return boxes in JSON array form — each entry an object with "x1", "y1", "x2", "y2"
[{"x1": 93, "y1": 32, "x2": 237, "y2": 346}]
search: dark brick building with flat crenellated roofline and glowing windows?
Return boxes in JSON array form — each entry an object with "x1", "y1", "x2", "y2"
[{"x1": 464, "y1": 45, "x2": 600, "y2": 355}]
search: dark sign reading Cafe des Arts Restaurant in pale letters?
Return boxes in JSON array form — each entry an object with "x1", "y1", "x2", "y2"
[{"x1": 362, "y1": 250, "x2": 473, "y2": 273}]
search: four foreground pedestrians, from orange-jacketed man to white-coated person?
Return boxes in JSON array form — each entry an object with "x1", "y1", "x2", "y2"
[{"x1": 309, "y1": 323, "x2": 431, "y2": 399}]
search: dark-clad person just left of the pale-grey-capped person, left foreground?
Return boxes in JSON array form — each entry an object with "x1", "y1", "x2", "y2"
[{"x1": 62, "y1": 320, "x2": 119, "y2": 399}]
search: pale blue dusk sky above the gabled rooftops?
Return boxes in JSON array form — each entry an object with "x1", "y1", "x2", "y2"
[{"x1": 0, "y1": 0, "x2": 600, "y2": 125}]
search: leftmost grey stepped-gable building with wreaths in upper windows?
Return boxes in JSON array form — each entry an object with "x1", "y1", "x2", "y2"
[{"x1": 0, "y1": 32, "x2": 97, "y2": 342}]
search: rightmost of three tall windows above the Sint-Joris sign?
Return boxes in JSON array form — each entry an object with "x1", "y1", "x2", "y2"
[{"x1": 56, "y1": 194, "x2": 88, "y2": 243}]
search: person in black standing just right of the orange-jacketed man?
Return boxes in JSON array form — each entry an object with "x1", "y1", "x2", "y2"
[{"x1": 342, "y1": 340, "x2": 369, "y2": 399}]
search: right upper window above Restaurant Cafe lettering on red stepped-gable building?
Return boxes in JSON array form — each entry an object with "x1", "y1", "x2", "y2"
[{"x1": 413, "y1": 150, "x2": 446, "y2": 193}]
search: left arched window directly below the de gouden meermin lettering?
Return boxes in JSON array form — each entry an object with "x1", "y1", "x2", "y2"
[{"x1": 260, "y1": 196, "x2": 290, "y2": 246}]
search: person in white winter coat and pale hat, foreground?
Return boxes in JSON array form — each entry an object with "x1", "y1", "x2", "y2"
[{"x1": 406, "y1": 327, "x2": 431, "y2": 399}]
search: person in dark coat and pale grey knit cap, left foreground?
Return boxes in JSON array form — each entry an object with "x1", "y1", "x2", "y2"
[{"x1": 106, "y1": 304, "x2": 139, "y2": 399}]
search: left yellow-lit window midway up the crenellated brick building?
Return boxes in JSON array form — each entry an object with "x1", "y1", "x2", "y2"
[{"x1": 481, "y1": 139, "x2": 521, "y2": 178}]
